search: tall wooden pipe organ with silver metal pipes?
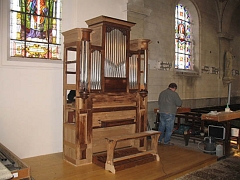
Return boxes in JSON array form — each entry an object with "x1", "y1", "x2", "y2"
[{"x1": 63, "y1": 16, "x2": 152, "y2": 165}]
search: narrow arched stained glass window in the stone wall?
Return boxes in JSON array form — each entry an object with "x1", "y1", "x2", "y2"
[{"x1": 175, "y1": 4, "x2": 193, "y2": 69}]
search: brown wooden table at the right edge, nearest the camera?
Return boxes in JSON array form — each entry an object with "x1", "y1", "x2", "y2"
[{"x1": 201, "y1": 110, "x2": 240, "y2": 156}]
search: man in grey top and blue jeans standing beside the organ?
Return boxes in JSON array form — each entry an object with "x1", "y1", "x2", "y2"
[{"x1": 158, "y1": 83, "x2": 182, "y2": 145}]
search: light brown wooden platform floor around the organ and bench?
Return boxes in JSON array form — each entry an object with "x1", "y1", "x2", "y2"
[{"x1": 23, "y1": 145, "x2": 217, "y2": 180}]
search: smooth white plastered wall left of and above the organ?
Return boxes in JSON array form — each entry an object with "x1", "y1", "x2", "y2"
[{"x1": 0, "y1": 0, "x2": 127, "y2": 158}]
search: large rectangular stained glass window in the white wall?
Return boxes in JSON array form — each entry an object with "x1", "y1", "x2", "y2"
[{"x1": 10, "y1": 0, "x2": 61, "y2": 60}]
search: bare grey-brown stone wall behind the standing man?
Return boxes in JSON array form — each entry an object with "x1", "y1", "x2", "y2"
[{"x1": 127, "y1": 0, "x2": 240, "y2": 129}]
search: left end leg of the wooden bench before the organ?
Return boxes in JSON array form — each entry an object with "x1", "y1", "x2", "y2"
[{"x1": 105, "y1": 141, "x2": 117, "y2": 174}]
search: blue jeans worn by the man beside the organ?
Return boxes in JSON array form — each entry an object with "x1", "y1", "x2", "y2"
[{"x1": 158, "y1": 113, "x2": 175, "y2": 144}]
